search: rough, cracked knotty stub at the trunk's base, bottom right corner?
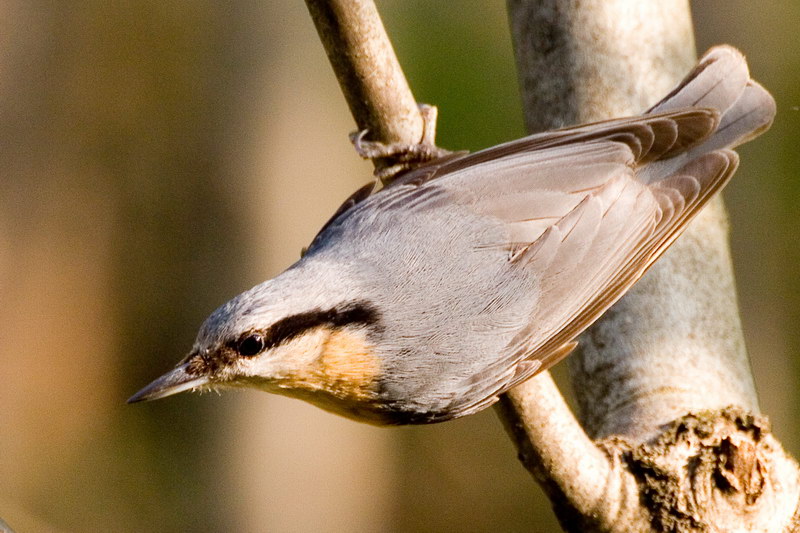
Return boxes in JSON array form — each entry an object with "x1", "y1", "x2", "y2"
[{"x1": 598, "y1": 406, "x2": 800, "y2": 532}]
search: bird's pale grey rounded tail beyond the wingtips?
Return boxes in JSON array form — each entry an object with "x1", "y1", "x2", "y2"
[{"x1": 641, "y1": 45, "x2": 775, "y2": 183}]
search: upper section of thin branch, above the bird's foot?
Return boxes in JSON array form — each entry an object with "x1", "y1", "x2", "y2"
[{"x1": 306, "y1": 0, "x2": 423, "y2": 174}]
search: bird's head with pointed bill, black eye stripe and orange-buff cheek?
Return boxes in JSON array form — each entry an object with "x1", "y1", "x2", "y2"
[{"x1": 128, "y1": 268, "x2": 381, "y2": 418}]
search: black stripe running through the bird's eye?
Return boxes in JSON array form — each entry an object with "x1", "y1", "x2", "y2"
[{"x1": 232, "y1": 302, "x2": 380, "y2": 351}]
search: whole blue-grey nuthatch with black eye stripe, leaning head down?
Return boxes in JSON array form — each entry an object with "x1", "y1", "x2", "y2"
[{"x1": 129, "y1": 45, "x2": 776, "y2": 426}]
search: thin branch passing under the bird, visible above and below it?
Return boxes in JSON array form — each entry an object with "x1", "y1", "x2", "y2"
[{"x1": 306, "y1": 0, "x2": 612, "y2": 510}]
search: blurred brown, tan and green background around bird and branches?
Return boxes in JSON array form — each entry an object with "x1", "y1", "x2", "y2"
[{"x1": 0, "y1": 0, "x2": 800, "y2": 533}]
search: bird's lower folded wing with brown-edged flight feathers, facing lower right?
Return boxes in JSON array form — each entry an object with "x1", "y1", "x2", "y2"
[{"x1": 440, "y1": 150, "x2": 738, "y2": 418}]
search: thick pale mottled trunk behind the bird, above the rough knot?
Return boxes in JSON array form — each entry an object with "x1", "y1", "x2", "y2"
[{"x1": 509, "y1": 0, "x2": 758, "y2": 439}]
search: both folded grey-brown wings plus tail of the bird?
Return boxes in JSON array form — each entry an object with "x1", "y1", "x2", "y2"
[{"x1": 309, "y1": 47, "x2": 775, "y2": 420}]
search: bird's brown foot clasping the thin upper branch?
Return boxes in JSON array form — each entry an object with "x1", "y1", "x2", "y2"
[{"x1": 350, "y1": 104, "x2": 452, "y2": 184}]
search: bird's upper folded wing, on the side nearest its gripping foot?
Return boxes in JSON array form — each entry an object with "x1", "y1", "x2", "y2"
[{"x1": 309, "y1": 109, "x2": 719, "y2": 252}]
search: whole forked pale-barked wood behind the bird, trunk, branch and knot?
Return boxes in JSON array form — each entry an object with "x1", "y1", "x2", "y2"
[{"x1": 307, "y1": 0, "x2": 800, "y2": 531}]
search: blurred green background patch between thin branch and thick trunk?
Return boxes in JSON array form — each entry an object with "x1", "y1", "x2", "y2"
[{"x1": 379, "y1": 0, "x2": 525, "y2": 150}]
